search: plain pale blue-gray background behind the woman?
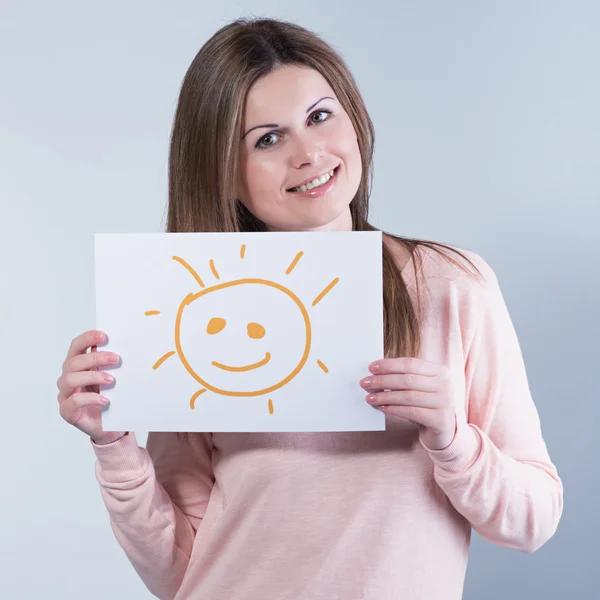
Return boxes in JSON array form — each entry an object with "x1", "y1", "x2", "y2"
[{"x1": 0, "y1": 0, "x2": 600, "y2": 600}]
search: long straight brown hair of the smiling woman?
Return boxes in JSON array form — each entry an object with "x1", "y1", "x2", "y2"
[{"x1": 167, "y1": 19, "x2": 478, "y2": 366}]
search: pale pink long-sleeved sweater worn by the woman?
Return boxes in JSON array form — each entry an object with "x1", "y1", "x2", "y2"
[{"x1": 92, "y1": 245, "x2": 563, "y2": 600}]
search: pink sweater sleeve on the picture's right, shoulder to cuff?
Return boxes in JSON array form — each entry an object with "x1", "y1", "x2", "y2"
[{"x1": 421, "y1": 254, "x2": 563, "y2": 552}]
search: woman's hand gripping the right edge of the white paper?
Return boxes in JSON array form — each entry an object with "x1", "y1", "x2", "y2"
[{"x1": 360, "y1": 358, "x2": 456, "y2": 450}]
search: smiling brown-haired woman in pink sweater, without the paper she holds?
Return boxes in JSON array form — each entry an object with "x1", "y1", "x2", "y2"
[{"x1": 58, "y1": 20, "x2": 563, "y2": 600}]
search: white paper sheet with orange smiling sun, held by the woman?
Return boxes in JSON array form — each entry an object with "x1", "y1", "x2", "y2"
[{"x1": 95, "y1": 232, "x2": 385, "y2": 432}]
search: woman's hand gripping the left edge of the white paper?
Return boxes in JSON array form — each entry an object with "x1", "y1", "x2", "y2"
[{"x1": 56, "y1": 331, "x2": 127, "y2": 444}]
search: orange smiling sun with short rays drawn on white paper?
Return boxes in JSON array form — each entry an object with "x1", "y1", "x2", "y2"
[{"x1": 144, "y1": 244, "x2": 339, "y2": 414}]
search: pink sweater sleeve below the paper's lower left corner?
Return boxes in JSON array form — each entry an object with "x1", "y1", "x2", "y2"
[{"x1": 91, "y1": 432, "x2": 214, "y2": 599}]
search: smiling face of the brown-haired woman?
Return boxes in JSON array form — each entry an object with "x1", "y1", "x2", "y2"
[{"x1": 238, "y1": 65, "x2": 362, "y2": 231}]
